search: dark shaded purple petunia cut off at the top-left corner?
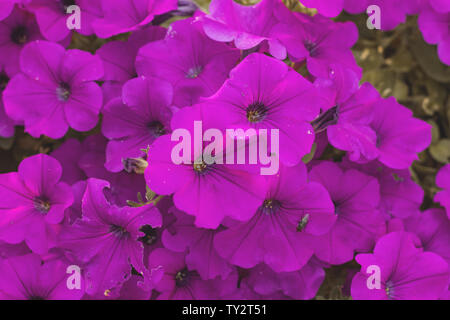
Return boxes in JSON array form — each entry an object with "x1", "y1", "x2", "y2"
[{"x1": 0, "y1": 8, "x2": 43, "y2": 75}]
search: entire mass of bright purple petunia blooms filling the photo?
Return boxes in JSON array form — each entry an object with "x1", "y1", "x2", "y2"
[{"x1": 0, "y1": 0, "x2": 450, "y2": 299}]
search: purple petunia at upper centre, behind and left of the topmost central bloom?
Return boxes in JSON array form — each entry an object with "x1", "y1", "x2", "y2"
[{"x1": 136, "y1": 18, "x2": 240, "y2": 107}]
